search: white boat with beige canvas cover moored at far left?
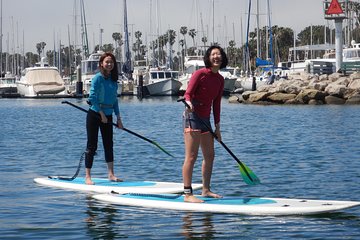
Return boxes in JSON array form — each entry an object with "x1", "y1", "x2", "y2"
[{"x1": 16, "y1": 57, "x2": 65, "y2": 97}]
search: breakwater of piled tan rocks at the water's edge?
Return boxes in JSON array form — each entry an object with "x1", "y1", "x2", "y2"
[{"x1": 229, "y1": 72, "x2": 360, "y2": 105}]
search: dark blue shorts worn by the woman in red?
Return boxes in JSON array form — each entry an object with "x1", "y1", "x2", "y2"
[{"x1": 183, "y1": 111, "x2": 211, "y2": 133}]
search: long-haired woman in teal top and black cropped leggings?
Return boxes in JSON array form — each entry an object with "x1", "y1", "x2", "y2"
[{"x1": 85, "y1": 53, "x2": 123, "y2": 184}]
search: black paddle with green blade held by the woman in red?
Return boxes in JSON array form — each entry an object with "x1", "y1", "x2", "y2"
[{"x1": 177, "y1": 98, "x2": 260, "y2": 185}]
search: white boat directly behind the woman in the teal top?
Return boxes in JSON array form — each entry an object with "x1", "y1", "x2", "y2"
[{"x1": 81, "y1": 51, "x2": 122, "y2": 95}]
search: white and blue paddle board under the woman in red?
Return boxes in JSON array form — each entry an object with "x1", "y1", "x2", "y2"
[{"x1": 93, "y1": 193, "x2": 360, "y2": 215}]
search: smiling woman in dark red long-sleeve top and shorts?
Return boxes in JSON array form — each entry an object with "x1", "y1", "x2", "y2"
[{"x1": 183, "y1": 46, "x2": 228, "y2": 203}]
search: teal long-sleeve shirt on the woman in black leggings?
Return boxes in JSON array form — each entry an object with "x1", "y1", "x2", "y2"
[{"x1": 88, "y1": 72, "x2": 119, "y2": 116}]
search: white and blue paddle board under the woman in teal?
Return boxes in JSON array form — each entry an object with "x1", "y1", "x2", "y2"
[{"x1": 34, "y1": 177, "x2": 202, "y2": 193}]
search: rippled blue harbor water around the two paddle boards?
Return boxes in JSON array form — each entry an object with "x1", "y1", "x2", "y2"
[{"x1": 0, "y1": 97, "x2": 360, "y2": 239}]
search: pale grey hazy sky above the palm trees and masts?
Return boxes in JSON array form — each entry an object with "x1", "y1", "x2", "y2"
[{"x1": 0, "y1": 0, "x2": 334, "y2": 53}]
